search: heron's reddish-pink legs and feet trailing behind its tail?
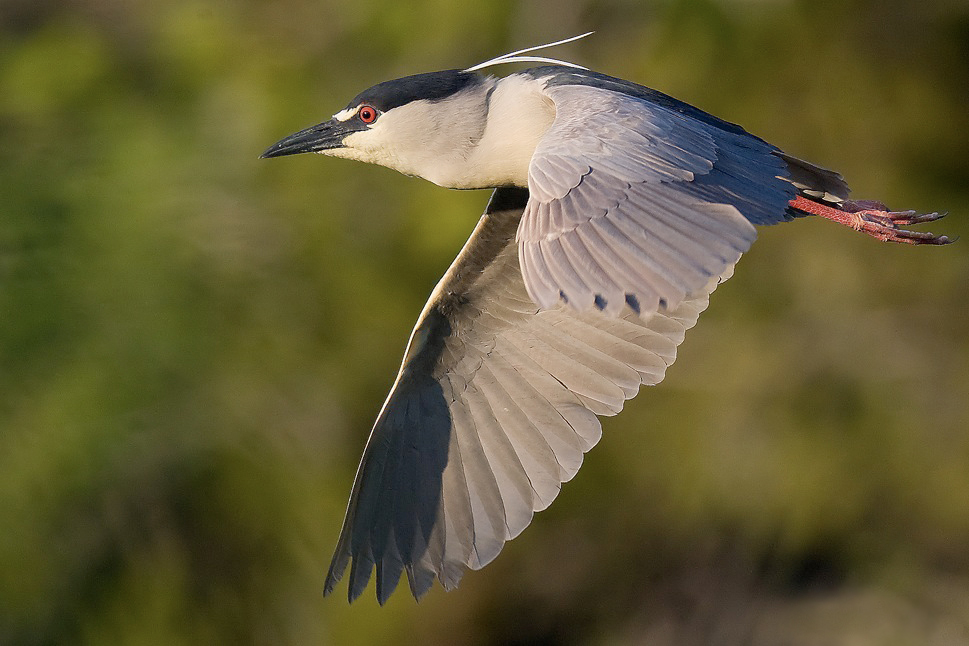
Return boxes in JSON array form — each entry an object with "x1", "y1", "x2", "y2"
[{"x1": 789, "y1": 195, "x2": 953, "y2": 244}]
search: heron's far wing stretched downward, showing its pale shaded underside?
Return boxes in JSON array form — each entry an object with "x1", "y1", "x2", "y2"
[{"x1": 326, "y1": 189, "x2": 732, "y2": 603}]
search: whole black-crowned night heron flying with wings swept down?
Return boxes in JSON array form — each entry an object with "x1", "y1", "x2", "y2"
[{"x1": 262, "y1": 32, "x2": 952, "y2": 605}]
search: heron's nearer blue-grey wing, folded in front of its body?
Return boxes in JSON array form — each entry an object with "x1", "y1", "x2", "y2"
[{"x1": 517, "y1": 84, "x2": 796, "y2": 315}]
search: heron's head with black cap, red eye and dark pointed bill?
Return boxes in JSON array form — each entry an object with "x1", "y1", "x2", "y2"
[{"x1": 262, "y1": 70, "x2": 494, "y2": 186}]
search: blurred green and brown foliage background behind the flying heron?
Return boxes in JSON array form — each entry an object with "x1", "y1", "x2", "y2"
[{"x1": 0, "y1": 0, "x2": 969, "y2": 645}]
